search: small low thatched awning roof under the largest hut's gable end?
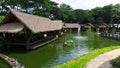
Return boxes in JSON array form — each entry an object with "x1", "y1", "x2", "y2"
[{"x1": 0, "y1": 23, "x2": 24, "y2": 33}]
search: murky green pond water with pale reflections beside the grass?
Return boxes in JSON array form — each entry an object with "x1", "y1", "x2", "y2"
[{"x1": 2, "y1": 33, "x2": 120, "y2": 68}]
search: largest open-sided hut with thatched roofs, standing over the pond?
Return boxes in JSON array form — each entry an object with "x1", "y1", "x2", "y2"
[{"x1": 0, "y1": 11, "x2": 63, "y2": 49}]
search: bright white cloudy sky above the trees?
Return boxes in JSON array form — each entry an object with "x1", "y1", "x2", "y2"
[{"x1": 51, "y1": 0, "x2": 120, "y2": 10}]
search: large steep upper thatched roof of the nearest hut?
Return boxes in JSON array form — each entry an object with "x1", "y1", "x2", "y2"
[{"x1": 2, "y1": 11, "x2": 62, "y2": 33}]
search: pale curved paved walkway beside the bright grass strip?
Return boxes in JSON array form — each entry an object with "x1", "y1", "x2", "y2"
[{"x1": 86, "y1": 49, "x2": 120, "y2": 68}]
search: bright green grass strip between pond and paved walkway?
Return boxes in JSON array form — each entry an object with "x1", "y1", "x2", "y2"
[{"x1": 52, "y1": 46, "x2": 120, "y2": 68}]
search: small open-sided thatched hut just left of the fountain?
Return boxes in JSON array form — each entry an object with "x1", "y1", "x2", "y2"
[{"x1": 64, "y1": 23, "x2": 80, "y2": 31}]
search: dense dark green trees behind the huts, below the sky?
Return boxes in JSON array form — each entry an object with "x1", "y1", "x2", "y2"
[{"x1": 0, "y1": 0, "x2": 120, "y2": 24}]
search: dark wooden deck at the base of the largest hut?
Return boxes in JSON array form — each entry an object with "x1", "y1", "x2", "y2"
[{"x1": 6, "y1": 36, "x2": 57, "y2": 49}]
